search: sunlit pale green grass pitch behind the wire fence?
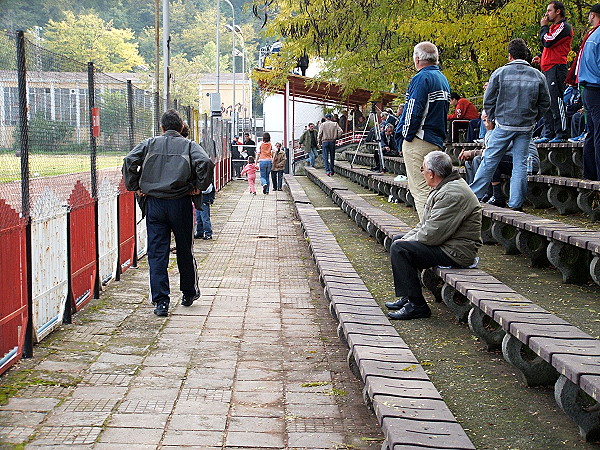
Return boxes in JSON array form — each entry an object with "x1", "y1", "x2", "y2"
[{"x1": 0, "y1": 152, "x2": 125, "y2": 183}]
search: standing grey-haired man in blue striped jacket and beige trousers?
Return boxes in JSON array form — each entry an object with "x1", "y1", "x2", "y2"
[{"x1": 395, "y1": 42, "x2": 450, "y2": 219}]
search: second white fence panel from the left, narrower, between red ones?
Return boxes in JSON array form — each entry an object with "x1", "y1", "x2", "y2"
[{"x1": 98, "y1": 178, "x2": 119, "y2": 285}]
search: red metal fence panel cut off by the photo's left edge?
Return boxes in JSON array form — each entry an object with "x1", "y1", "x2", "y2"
[{"x1": 0, "y1": 199, "x2": 28, "y2": 374}]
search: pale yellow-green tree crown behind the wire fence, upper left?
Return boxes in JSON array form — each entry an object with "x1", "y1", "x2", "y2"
[{"x1": 43, "y1": 12, "x2": 144, "y2": 72}]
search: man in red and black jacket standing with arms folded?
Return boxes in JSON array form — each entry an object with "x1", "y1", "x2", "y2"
[{"x1": 533, "y1": 1, "x2": 573, "y2": 144}]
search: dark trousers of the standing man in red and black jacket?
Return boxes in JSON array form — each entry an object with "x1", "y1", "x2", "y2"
[{"x1": 542, "y1": 64, "x2": 569, "y2": 139}]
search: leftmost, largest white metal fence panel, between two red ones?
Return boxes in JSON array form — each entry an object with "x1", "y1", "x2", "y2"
[{"x1": 31, "y1": 188, "x2": 69, "y2": 342}]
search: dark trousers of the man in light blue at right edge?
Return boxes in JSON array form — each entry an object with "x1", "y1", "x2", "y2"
[{"x1": 583, "y1": 87, "x2": 600, "y2": 181}]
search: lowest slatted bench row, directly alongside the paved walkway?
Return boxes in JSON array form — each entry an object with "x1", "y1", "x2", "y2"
[{"x1": 284, "y1": 173, "x2": 475, "y2": 450}]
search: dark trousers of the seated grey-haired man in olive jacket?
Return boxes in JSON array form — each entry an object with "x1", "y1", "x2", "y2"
[{"x1": 390, "y1": 239, "x2": 456, "y2": 305}]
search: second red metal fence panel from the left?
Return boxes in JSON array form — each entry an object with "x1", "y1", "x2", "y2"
[{"x1": 68, "y1": 180, "x2": 98, "y2": 311}]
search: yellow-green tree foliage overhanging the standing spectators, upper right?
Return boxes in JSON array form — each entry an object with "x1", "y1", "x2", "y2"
[{"x1": 254, "y1": 0, "x2": 585, "y2": 95}]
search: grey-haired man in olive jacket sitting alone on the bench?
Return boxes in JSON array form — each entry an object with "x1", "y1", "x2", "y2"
[{"x1": 385, "y1": 151, "x2": 482, "y2": 320}]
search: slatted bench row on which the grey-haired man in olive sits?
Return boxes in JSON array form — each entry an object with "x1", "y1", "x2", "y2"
[{"x1": 308, "y1": 166, "x2": 600, "y2": 440}]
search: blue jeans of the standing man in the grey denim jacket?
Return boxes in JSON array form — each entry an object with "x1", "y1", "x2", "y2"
[{"x1": 470, "y1": 127, "x2": 533, "y2": 208}]
